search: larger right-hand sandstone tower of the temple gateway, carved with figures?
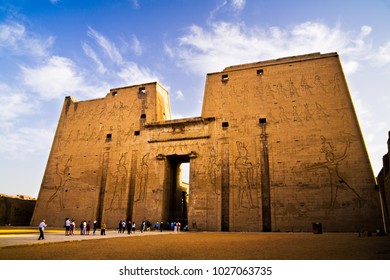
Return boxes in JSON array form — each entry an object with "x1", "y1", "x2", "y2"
[{"x1": 202, "y1": 54, "x2": 380, "y2": 231}]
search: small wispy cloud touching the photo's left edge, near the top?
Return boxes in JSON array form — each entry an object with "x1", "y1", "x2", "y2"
[{"x1": 0, "y1": 22, "x2": 54, "y2": 57}]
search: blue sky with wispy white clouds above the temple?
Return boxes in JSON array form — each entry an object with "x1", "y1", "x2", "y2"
[{"x1": 0, "y1": 0, "x2": 390, "y2": 197}]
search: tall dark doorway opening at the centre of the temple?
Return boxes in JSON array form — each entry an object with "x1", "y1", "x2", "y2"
[{"x1": 163, "y1": 155, "x2": 190, "y2": 228}]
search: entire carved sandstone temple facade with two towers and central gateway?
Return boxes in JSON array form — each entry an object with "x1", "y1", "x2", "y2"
[{"x1": 31, "y1": 53, "x2": 382, "y2": 232}]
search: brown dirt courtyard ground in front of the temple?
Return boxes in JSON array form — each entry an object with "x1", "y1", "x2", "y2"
[{"x1": 0, "y1": 232, "x2": 390, "y2": 260}]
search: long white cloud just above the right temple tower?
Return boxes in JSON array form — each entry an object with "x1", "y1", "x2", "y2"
[{"x1": 172, "y1": 21, "x2": 372, "y2": 74}]
